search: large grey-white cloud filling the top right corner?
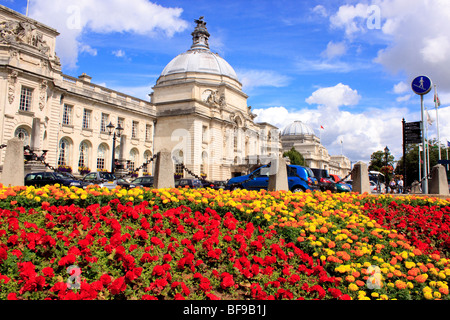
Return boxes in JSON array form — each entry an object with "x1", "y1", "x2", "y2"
[{"x1": 330, "y1": 0, "x2": 450, "y2": 92}]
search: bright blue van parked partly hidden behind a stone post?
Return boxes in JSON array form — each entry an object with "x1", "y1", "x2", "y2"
[{"x1": 227, "y1": 165, "x2": 319, "y2": 192}]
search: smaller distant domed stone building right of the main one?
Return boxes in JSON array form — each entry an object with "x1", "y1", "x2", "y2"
[{"x1": 281, "y1": 120, "x2": 351, "y2": 178}]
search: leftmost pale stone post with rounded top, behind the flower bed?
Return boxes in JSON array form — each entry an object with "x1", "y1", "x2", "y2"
[{"x1": 1, "y1": 138, "x2": 25, "y2": 186}]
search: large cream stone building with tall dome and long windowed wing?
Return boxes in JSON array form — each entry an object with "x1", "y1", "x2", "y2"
[{"x1": 0, "y1": 6, "x2": 281, "y2": 180}]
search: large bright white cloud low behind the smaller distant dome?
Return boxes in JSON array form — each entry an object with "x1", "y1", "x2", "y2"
[{"x1": 253, "y1": 83, "x2": 418, "y2": 163}]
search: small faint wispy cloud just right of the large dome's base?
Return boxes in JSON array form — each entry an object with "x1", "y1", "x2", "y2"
[{"x1": 236, "y1": 70, "x2": 290, "y2": 90}]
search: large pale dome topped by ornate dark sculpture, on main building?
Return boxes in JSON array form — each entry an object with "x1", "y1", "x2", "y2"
[{"x1": 161, "y1": 17, "x2": 239, "y2": 81}]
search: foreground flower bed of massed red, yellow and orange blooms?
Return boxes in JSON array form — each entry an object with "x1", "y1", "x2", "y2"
[{"x1": 0, "y1": 186, "x2": 450, "y2": 300}]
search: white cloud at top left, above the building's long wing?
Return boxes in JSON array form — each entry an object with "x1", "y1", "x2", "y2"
[{"x1": 29, "y1": 0, "x2": 188, "y2": 69}]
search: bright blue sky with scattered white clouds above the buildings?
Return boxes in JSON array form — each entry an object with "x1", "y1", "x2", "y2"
[{"x1": 0, "y1": 0, "x2": 450, "y2": 162}]
